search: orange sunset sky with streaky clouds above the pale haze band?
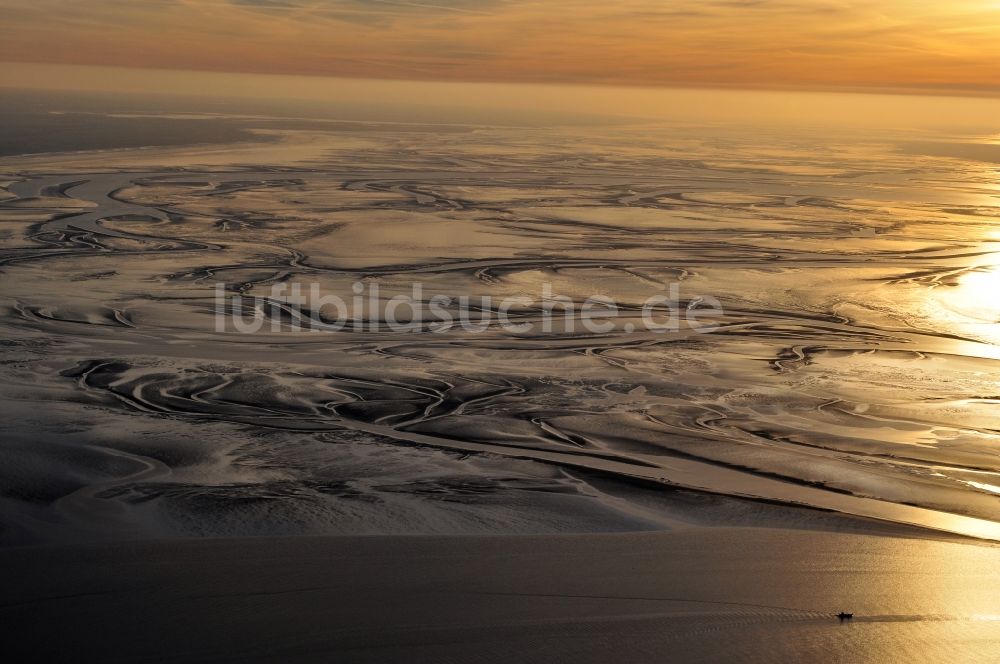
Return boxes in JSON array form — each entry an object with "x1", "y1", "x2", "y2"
[{"x1": 0, "y1": 0, "x2": 1000, "y2": 95}]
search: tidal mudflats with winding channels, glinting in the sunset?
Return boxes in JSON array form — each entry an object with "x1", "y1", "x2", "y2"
[{"x1": 0, "y1": 109, "x2": 1000, "y2": 541}]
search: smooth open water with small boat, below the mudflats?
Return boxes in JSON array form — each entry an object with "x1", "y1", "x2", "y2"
[{"x1": 0, "y1": 528, "x2": 1000, "y2": 662}]
